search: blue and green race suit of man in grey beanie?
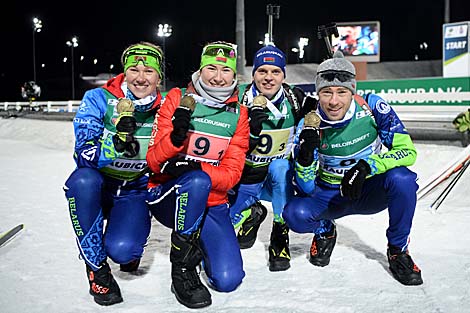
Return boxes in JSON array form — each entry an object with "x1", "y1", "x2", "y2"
[{"x1": 283, "y1": 94, "x2": 418, "y2": 250}]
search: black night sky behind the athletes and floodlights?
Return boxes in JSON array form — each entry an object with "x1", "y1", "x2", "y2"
[{"x1": 0, "y1": 0, "x2": 470, "y2": 101}]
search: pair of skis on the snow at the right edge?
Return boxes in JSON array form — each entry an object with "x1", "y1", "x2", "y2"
[{"x1": 417, "y1": 145, "x2": 470, "y2": 211}]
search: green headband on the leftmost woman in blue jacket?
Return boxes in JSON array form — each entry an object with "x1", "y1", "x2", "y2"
[{"x1": 122, "y1": 45, "x2": 163, "y2": 78}]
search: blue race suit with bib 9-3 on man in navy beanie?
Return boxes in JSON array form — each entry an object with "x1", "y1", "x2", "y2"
[{"x1": 229, "y1": 84, "x2": 304, "y2": 224}]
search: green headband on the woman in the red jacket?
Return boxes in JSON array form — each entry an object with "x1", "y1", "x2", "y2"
[{"x1": 199, "y1": 43, "x2": 237, "y2": 74}]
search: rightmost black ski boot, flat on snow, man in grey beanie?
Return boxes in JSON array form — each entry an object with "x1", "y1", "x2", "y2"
[{"x1": 387, "y1": 246, "x2": 423, "y2": 286}]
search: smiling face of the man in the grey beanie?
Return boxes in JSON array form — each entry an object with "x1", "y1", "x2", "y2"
[{"x1": 318, "y1": 87, "x2": 353, "y2": 121}]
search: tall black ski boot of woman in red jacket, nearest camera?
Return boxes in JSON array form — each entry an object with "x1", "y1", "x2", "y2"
[{"x1": 170, "y1": 231, "x2": 212, "y2": 309}]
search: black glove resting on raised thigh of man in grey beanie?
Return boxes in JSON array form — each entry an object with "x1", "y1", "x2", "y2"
[{"x1": 340, "y1": 159, "x2": 370, "y2": 200}]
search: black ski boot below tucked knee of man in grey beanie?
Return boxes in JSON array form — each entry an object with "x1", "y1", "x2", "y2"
[{"x1": 309, "y1": 224, "x2": 337, "y2": 267}]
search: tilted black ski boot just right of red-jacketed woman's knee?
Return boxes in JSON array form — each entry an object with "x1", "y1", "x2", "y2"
[{"x1": 237, "y1": 201, "x2": 268, "y2": 249}]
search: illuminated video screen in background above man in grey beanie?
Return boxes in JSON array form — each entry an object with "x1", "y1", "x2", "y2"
[{"x1": 331, "y1": 21, "x2": 380, "y2": 62}]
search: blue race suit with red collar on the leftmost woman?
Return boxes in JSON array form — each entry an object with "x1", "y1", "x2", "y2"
[{"x1": 64, "y1": 74, "x2": 161, "y2": 270}]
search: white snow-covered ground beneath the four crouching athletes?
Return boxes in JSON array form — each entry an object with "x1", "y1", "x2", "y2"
[{"x1": 0, "y1": 119, "x2": 470, "y2": 313}]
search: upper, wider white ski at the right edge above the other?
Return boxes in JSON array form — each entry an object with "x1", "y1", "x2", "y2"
[{"x1": 417, "y1": 145, "x2": 470, "y2": 200}]
